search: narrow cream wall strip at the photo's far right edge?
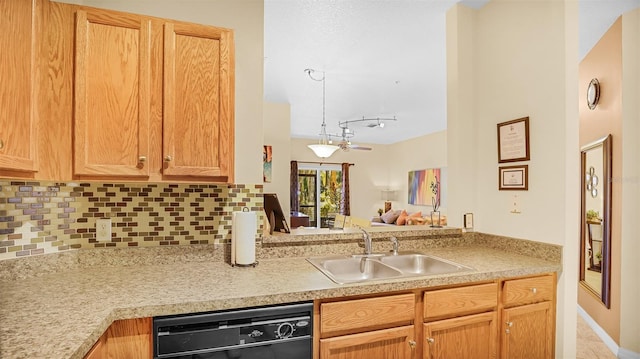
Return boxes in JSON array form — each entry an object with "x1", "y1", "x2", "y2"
[{"x1": 614, "y1": 9, "x2": 640, "y2": 357}]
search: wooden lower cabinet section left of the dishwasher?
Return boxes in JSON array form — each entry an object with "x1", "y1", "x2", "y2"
[{"x1": 85, "y1": 318, "x2": 153, "y2": 359}]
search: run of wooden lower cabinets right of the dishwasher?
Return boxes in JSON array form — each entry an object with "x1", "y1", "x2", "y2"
[{"x1": 314, "y1": 273, "x2": 556, "y2": 359}]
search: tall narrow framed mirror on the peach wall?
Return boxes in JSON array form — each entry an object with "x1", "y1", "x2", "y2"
[{"x1": 580, "y1": 135, "x2": 612, "y2": 308}]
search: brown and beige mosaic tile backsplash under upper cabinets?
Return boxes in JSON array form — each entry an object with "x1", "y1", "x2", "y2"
[{"x1": 0, "y1": 180, "x2": 264, "y2": 260}]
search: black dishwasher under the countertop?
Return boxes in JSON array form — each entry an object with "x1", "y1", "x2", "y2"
[{"x1": 153, "y1": 302, "x2": 313, "y2": 359}]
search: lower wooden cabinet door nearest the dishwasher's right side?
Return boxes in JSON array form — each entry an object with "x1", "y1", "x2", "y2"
[{"x1": 320, "y1": 325, "x2": 416, "y2": 359}]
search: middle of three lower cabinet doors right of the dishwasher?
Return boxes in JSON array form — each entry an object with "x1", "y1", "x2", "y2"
[{"x1": 423, "y1": 312, "x2": 498, "y2": 359}]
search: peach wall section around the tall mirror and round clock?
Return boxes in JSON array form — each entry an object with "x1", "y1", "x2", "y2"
[{"x1": 578, "y1": 18, "x2": 623, "y2": 343}]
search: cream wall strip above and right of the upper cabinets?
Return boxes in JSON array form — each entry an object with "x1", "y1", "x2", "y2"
[{"x1": 61, "y1": 0, "x2": 264, "y2": 183}]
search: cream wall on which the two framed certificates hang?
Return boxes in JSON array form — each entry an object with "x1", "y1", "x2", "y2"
[{"x1": 447, "y1": 0, "x2": 580, "y2": 358}]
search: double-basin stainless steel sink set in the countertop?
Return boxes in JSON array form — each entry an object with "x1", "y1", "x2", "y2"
[{"x1": 307, "y1": 252, "x2": 474, "y2": 284}]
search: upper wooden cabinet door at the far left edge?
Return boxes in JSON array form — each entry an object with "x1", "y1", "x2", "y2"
[{"x1": 0, "y1": 0, "x2": 38, "y2": 172}]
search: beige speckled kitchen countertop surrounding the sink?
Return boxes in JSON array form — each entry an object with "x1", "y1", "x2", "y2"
[{"x1": 0, "y1": 228, "x2": 561, "y2": 358}]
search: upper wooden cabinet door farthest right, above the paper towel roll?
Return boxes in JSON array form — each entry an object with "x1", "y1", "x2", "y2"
[{"x1": 162, "y1": 22, "x2": 234, "y2": 182}]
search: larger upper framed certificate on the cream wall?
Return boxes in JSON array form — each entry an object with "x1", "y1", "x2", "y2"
[{"x1": 498, "y1": 117, "x2": 530, "y2": 163}]
